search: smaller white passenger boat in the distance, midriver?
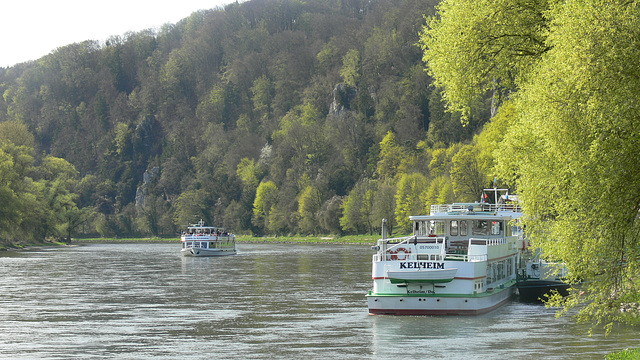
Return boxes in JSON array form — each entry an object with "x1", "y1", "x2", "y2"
[{"x1": 180, "y1": 220, "x2": 236, "y2": 256}]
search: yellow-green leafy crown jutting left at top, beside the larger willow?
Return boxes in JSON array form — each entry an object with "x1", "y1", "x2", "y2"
[{"x1": 420, "y1": 0, "x2": 554, "y2": 117}]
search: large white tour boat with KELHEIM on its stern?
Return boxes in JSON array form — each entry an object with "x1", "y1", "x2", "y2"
[{"x1": 367, "y1": 189, "x2": 523, "y2": 315}]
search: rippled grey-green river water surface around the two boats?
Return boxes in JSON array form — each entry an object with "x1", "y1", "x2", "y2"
[{"x1": 0, "y1": 242, "x2": 640, "y2": 359}]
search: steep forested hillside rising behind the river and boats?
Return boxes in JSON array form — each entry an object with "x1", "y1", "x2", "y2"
[{"x1": 0, "y1": 0, "x2": 496, "y2": 245}]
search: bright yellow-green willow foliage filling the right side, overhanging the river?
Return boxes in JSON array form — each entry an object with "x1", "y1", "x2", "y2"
[{"x1": 422, "y1": 0, "x2": 640, "y2": 330}]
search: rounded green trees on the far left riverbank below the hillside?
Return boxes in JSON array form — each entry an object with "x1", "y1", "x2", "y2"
[{"x1": 0, "y1": 134, "x2": 89, "y2": 242}]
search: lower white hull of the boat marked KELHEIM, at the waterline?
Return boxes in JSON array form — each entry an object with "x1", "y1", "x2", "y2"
[{"x1": 367, "y1": 286, "x2": 514, "y2": 315}]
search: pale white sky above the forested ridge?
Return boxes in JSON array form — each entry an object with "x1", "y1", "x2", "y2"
[{"x1": 0, "y1": 0, "x2": 235, "y2": 67}]
